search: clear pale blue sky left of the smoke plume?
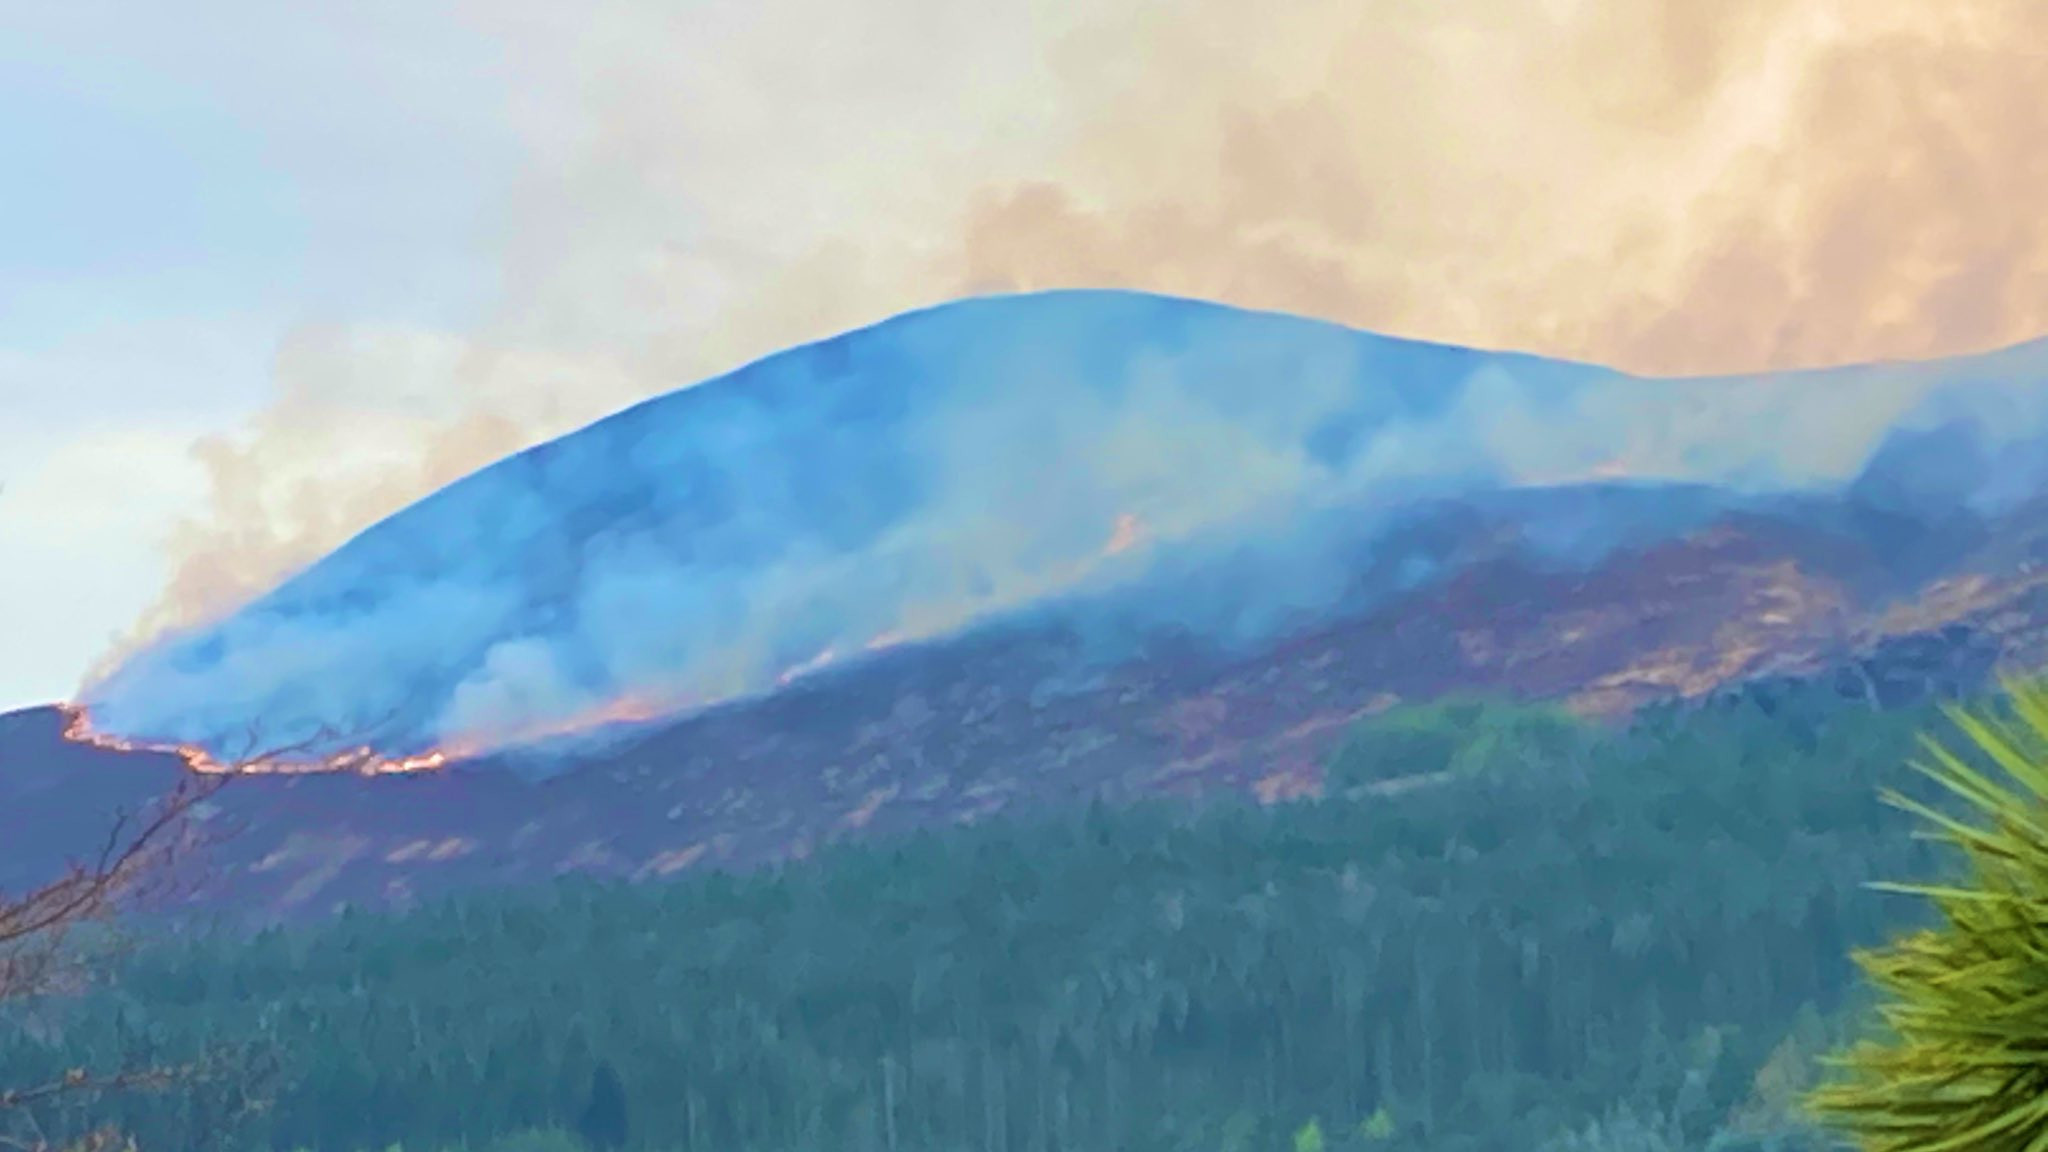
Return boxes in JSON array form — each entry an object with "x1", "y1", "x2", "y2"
[{"x1": 0, "y1": 2, "x2": 506, "y2": 707}]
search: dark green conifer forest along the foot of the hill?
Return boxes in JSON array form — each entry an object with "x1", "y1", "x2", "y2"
[{"x1": 0, "y1": 691, "x2": 1982, "y2": 1152}]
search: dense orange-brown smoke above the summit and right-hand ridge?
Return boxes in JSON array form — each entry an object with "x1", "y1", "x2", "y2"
[{"x1": 965, "y1": 0, "x2": 2048, "y2": 373}]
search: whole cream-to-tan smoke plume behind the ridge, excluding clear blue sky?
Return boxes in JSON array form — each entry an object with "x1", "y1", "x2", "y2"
[{"x1": 112, "y1": 0, "x2": 2048, "y2": 664}]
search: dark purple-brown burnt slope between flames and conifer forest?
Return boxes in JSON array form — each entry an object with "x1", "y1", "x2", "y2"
[{"x1": 0, "y1": 475, "x2": 2048, "y2": 914}]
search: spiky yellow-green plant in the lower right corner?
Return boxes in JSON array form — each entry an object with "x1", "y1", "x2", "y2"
[{"x1": 1812, "y1": 685, "x2": 2048, "y2": 1152}]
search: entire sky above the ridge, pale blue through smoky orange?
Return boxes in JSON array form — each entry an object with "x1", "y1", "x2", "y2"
[{"x1": 0, "y1": 0, "x2": 2048, "y2": 709}]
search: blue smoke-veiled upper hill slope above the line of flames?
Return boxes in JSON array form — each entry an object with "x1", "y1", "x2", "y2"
[{"x1": 82, "y1": 291, "x2": 2048, "y2": 754}]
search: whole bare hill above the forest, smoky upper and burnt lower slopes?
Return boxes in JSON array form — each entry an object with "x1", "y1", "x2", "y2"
[{"x1": 12, "y1": 293, "x2": 2048, "y2": 914}]
